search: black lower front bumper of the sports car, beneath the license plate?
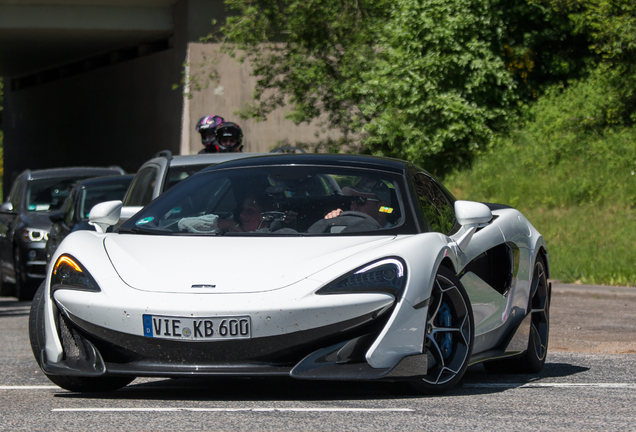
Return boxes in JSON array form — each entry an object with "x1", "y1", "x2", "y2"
[{"x1": 40, "y1": 296, "x2": 427, "y2": 380}]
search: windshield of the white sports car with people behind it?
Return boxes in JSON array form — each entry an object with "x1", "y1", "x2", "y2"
[{"x1": 120, "y1": 166, "x2": 404, "y2": 235}]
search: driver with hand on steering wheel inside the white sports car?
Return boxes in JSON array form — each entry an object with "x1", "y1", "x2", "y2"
[{"x1": 325, "y1": 178, "x2": 393, "y2": 228}]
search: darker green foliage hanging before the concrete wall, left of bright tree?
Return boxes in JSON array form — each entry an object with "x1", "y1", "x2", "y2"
[{"x1": 217, "y1": 0, "x2": 390, "y2": 149}]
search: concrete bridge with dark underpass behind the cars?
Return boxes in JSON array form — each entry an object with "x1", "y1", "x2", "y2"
[{"x1": 0, "y1": 0, "x2": 316, "y2": 197}]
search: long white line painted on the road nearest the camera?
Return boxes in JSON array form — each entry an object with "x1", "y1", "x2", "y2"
[{"x1": 51, "y1": 408, "x2": 415, "y2": 413}]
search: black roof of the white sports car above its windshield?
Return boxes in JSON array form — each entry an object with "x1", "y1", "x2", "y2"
[{"x1": 203, "y1": 153, "x2": 410, "y2": 173}]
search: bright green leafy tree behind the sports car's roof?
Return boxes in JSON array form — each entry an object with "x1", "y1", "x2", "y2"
[{"x1": 361, "y1": 0, "x2": 515, "y2": 175}]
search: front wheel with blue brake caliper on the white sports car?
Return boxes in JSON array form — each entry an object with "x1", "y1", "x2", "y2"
[{"x1": 409, "y1": 267, "x2": 475, "y2": 394}]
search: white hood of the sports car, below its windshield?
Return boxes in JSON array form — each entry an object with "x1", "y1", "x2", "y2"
[{"x1": 104, "y1": 235, "x2": 394, "y2": 294}]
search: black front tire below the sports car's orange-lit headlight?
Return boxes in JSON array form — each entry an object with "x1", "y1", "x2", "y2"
[{"x1": 29, "y1": 282, "x2": 135, "y2": 393}]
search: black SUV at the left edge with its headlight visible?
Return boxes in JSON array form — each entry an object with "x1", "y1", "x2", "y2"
[{"x1": 0, "y1": 167, "x2": 125, "y2": 300}]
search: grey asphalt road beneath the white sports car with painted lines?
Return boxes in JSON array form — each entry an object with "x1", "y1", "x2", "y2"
[{"x1": 0, "y1": 285, "x2": 636, "y2": 432}]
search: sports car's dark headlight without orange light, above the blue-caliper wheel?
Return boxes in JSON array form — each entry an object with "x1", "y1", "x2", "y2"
[{"x1": 316, "y1": 258, "x2": 406, "y2": 298}]
